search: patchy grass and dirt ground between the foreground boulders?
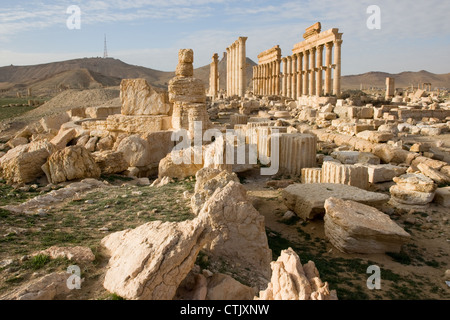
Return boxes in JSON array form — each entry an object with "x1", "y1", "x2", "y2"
[{"x1": 0, "y1": 171, "x2": 450, "y2": 299}]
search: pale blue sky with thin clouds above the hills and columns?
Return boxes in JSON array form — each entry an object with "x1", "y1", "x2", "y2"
[{"x1": 0, "y1": 0, "x2": 450, "y2": 75}]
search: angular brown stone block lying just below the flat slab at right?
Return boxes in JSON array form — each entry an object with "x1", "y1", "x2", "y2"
[{"x1": 324, "y1": 198, "x2": 410, "y2": 253}]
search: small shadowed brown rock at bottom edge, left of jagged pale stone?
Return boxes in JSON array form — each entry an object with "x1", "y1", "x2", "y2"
[{"x1": 206, "y1": 273, "x2": 255, "y2": 300}]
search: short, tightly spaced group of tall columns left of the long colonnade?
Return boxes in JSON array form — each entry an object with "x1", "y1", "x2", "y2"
[{"x1": 227, "y1": 37, "x2": 247, "y2": 97}]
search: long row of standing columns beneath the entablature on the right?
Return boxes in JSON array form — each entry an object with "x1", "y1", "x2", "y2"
[{"x1": 253, "y1": 40, "x2": 342, "y2": 99}]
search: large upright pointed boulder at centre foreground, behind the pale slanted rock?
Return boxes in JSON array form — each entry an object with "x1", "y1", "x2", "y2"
[{"x1": 199, "y1": 181, "x2": 272, "y2": 278}]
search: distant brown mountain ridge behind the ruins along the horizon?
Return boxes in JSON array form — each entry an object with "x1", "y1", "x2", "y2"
[{"x1": 0, "y1": 57, "x2": 450, "y2": 95}]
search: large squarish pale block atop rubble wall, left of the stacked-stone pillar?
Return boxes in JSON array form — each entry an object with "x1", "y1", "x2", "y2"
[{"x1": 120, "y1": 79, "x2": 172, "y2": 116}]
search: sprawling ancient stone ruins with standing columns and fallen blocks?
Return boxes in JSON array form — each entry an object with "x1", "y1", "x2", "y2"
[{"x1": 0, "y1": 23, "x2": 450, "y2": 300}]
